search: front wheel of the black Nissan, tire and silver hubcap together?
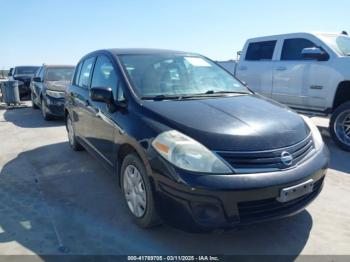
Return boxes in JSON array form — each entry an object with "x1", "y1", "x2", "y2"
[{"x1": 120, "y1": 153, "x2": 161, "y2": 228}]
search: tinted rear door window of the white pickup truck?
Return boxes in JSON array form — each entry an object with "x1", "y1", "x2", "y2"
[{"x1": 245, "y1": 40, "x2": 277, "y2": 61}]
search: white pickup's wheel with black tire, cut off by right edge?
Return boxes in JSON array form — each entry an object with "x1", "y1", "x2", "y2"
[{"x1": 329, "y1": 101, "x2": 350, "y2": 151}]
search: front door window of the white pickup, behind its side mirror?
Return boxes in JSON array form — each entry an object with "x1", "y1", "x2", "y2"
[{"x1": 281, "y1": 38, "x2": 317, "y2": 60}]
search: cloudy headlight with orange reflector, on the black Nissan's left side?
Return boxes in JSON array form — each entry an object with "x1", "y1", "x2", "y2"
[{"x1": 152, "y1": 130, "x2": 233, "y2": 174}]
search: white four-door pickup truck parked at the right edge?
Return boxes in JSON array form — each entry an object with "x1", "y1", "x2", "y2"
[{"x1": 236, "y1": 33, "x2": 350, "y2": 151}]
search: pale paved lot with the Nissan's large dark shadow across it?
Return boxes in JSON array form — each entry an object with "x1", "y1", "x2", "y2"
[{"x1": 0, "y1": 105, "x2": 350, "y2": 257}]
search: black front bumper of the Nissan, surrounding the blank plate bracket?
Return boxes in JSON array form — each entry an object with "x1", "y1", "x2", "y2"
[{"x1": 152, "y1": 146, "x2": 329, "y2": 230}]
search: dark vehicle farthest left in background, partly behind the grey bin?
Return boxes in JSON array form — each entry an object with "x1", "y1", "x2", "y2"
[{"x1": 8, "y1": 66, "x2": 39, "y2": 99}]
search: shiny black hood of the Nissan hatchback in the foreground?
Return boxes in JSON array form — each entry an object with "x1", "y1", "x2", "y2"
[{"x1": 143, "y1": 95, "x2": 310, "y2": 151}]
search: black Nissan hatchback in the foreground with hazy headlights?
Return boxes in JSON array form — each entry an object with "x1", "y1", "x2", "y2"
[{"x1": 65, "y1": 49, "x2": 328, "y2": 230}]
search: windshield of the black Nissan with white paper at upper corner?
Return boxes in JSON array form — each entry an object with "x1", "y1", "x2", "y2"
[{"x1": 120, "y1": 54, "x2": 250, "y2": 99}]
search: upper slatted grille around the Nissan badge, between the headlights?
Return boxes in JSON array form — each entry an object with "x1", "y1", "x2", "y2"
[{"x1": 217, "y1": 134, "x2": 314, "y2": 173}]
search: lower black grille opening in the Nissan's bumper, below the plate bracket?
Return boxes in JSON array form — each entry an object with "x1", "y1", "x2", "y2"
[{"x1": 238, "y1": 177, "x2": 324, "y2": 223}]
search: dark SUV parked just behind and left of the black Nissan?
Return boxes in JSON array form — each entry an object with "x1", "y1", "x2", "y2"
[{"x1": 30, "y1": 65, "x2": 74, "y2": 120}]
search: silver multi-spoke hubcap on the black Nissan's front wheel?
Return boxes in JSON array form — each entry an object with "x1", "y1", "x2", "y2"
[{"x1": 123, "y1": 165, "x2": 147, "y2": 217}]
